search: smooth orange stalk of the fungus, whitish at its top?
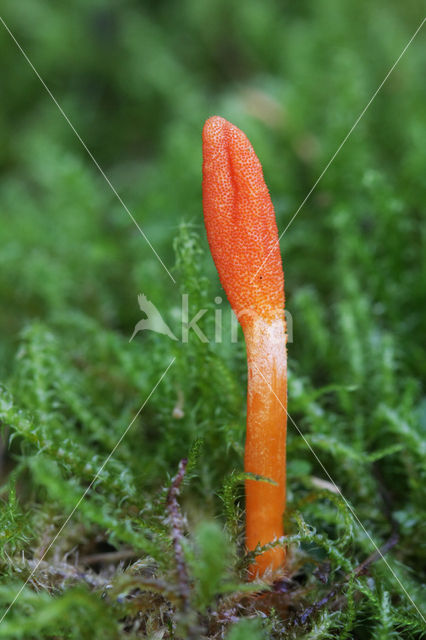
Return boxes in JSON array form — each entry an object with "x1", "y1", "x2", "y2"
[{"x1": 244, "y1": 314, "x2": 287, "y2": 579}]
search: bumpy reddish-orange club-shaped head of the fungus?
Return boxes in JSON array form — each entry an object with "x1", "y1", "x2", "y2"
[{"x1": 203, "y1": 116, "x2": 284, "y2": 327}]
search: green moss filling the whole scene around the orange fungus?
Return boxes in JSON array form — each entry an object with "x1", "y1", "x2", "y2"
[{"x1": 0, "y1": 0, "x2": 426, "y2": 640}]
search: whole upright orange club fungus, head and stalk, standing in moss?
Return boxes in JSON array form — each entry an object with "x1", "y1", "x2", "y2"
[{"x1": 203, "y1": 116, "x2": 287, "y2": 578}]
